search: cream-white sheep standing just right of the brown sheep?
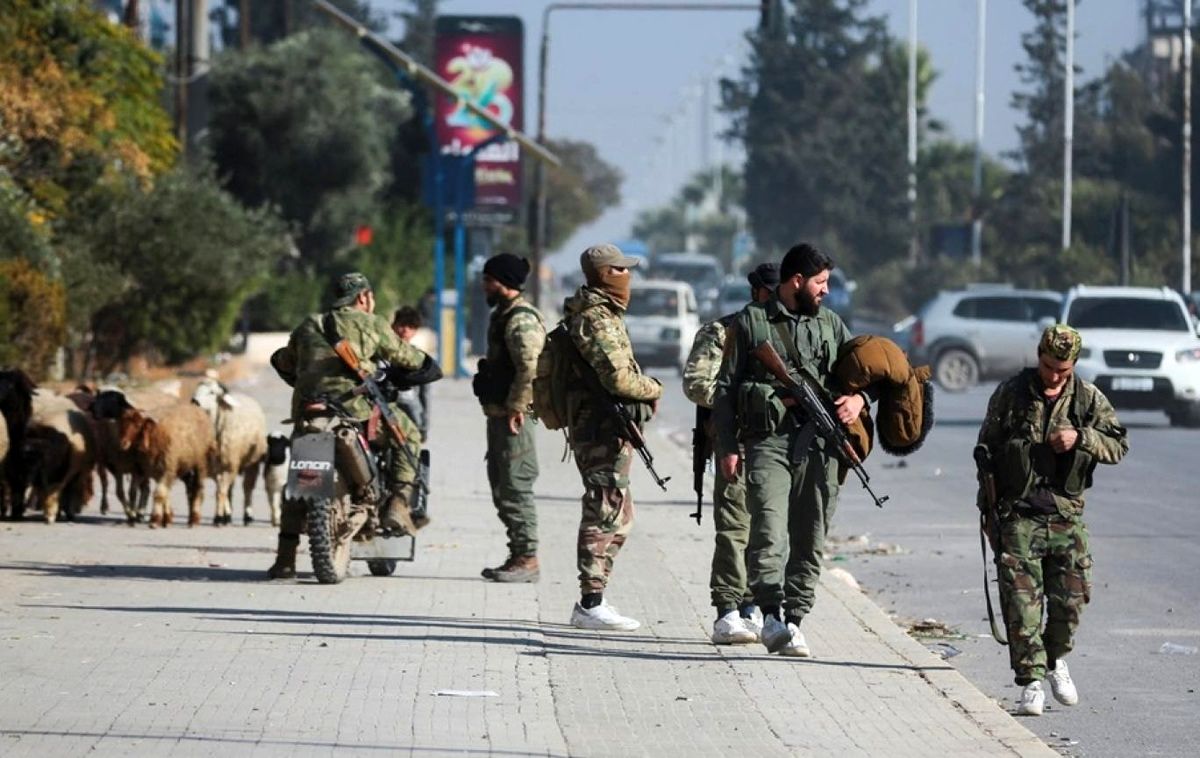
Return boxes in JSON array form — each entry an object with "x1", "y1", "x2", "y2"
[{"x1": 192, "y1": 379, "x2": 266, "y2": 525}]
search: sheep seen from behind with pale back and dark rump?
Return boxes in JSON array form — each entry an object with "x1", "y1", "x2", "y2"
[{"x1": 24, "y1": 390, "x2": 96, "y2": 524}]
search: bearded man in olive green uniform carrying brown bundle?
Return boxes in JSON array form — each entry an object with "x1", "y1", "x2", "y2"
[{"x1": 713, "y1": 245, "x2": 865, "y2": 657}]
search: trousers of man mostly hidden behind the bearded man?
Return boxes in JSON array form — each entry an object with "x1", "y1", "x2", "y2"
[{"x1": 708, "y1": 450, "x2": 754, "y2": 609}]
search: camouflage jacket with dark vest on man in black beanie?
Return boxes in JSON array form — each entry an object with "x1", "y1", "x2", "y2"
[{"x1": 484, "y1": 295, "x2": 546, "y2": 416}]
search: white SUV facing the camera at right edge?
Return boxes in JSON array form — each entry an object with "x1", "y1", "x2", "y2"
[{"x1": 1061, "y1": 285, "x2": 1200, "y2": 427}]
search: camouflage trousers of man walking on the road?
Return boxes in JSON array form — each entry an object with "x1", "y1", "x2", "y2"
[{"x1": 1000, "y1": 516, "x2": 1092, "y2": 685}]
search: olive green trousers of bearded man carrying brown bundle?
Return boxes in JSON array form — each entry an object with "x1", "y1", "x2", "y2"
[{"x1": 746, "y1": 431, "x2": 839, "y2": 619}]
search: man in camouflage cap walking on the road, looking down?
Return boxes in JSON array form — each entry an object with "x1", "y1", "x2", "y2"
[{"x1": 979, "y1": 324, "x2": 1129, "y2": 716}]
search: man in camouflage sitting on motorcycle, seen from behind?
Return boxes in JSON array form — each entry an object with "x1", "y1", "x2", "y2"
[{"x1": 268, "y1": 273, "x2": 430, "y2": 579}]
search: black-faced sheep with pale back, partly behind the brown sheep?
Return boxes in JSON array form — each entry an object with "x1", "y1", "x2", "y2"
[{"x1": 91, "y1": 387, "x2": 182, "y2": 527}]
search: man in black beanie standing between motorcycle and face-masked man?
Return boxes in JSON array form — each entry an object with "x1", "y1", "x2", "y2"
[{"x1": 474, "y1": 253, "x2": 546, "y2": 582}]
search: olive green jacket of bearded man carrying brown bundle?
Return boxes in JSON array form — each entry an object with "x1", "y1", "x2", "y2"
[{"x1": 713, "y1": 294, "x2": 852, "y2": 456}]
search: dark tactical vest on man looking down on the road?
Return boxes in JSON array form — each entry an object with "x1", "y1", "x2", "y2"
[{"x1": 996, "y1": 368, "x2": 1097, "y2": 501}]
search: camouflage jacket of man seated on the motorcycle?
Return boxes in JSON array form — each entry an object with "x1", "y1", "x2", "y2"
[{"x1": 271, "y1": 306, "x2": 425, "y2": 419}]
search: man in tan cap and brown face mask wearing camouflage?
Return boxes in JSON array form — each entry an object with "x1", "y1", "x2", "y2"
[{"x1": 563, "y1": 245, "x2": 662, "y2": 631}]
